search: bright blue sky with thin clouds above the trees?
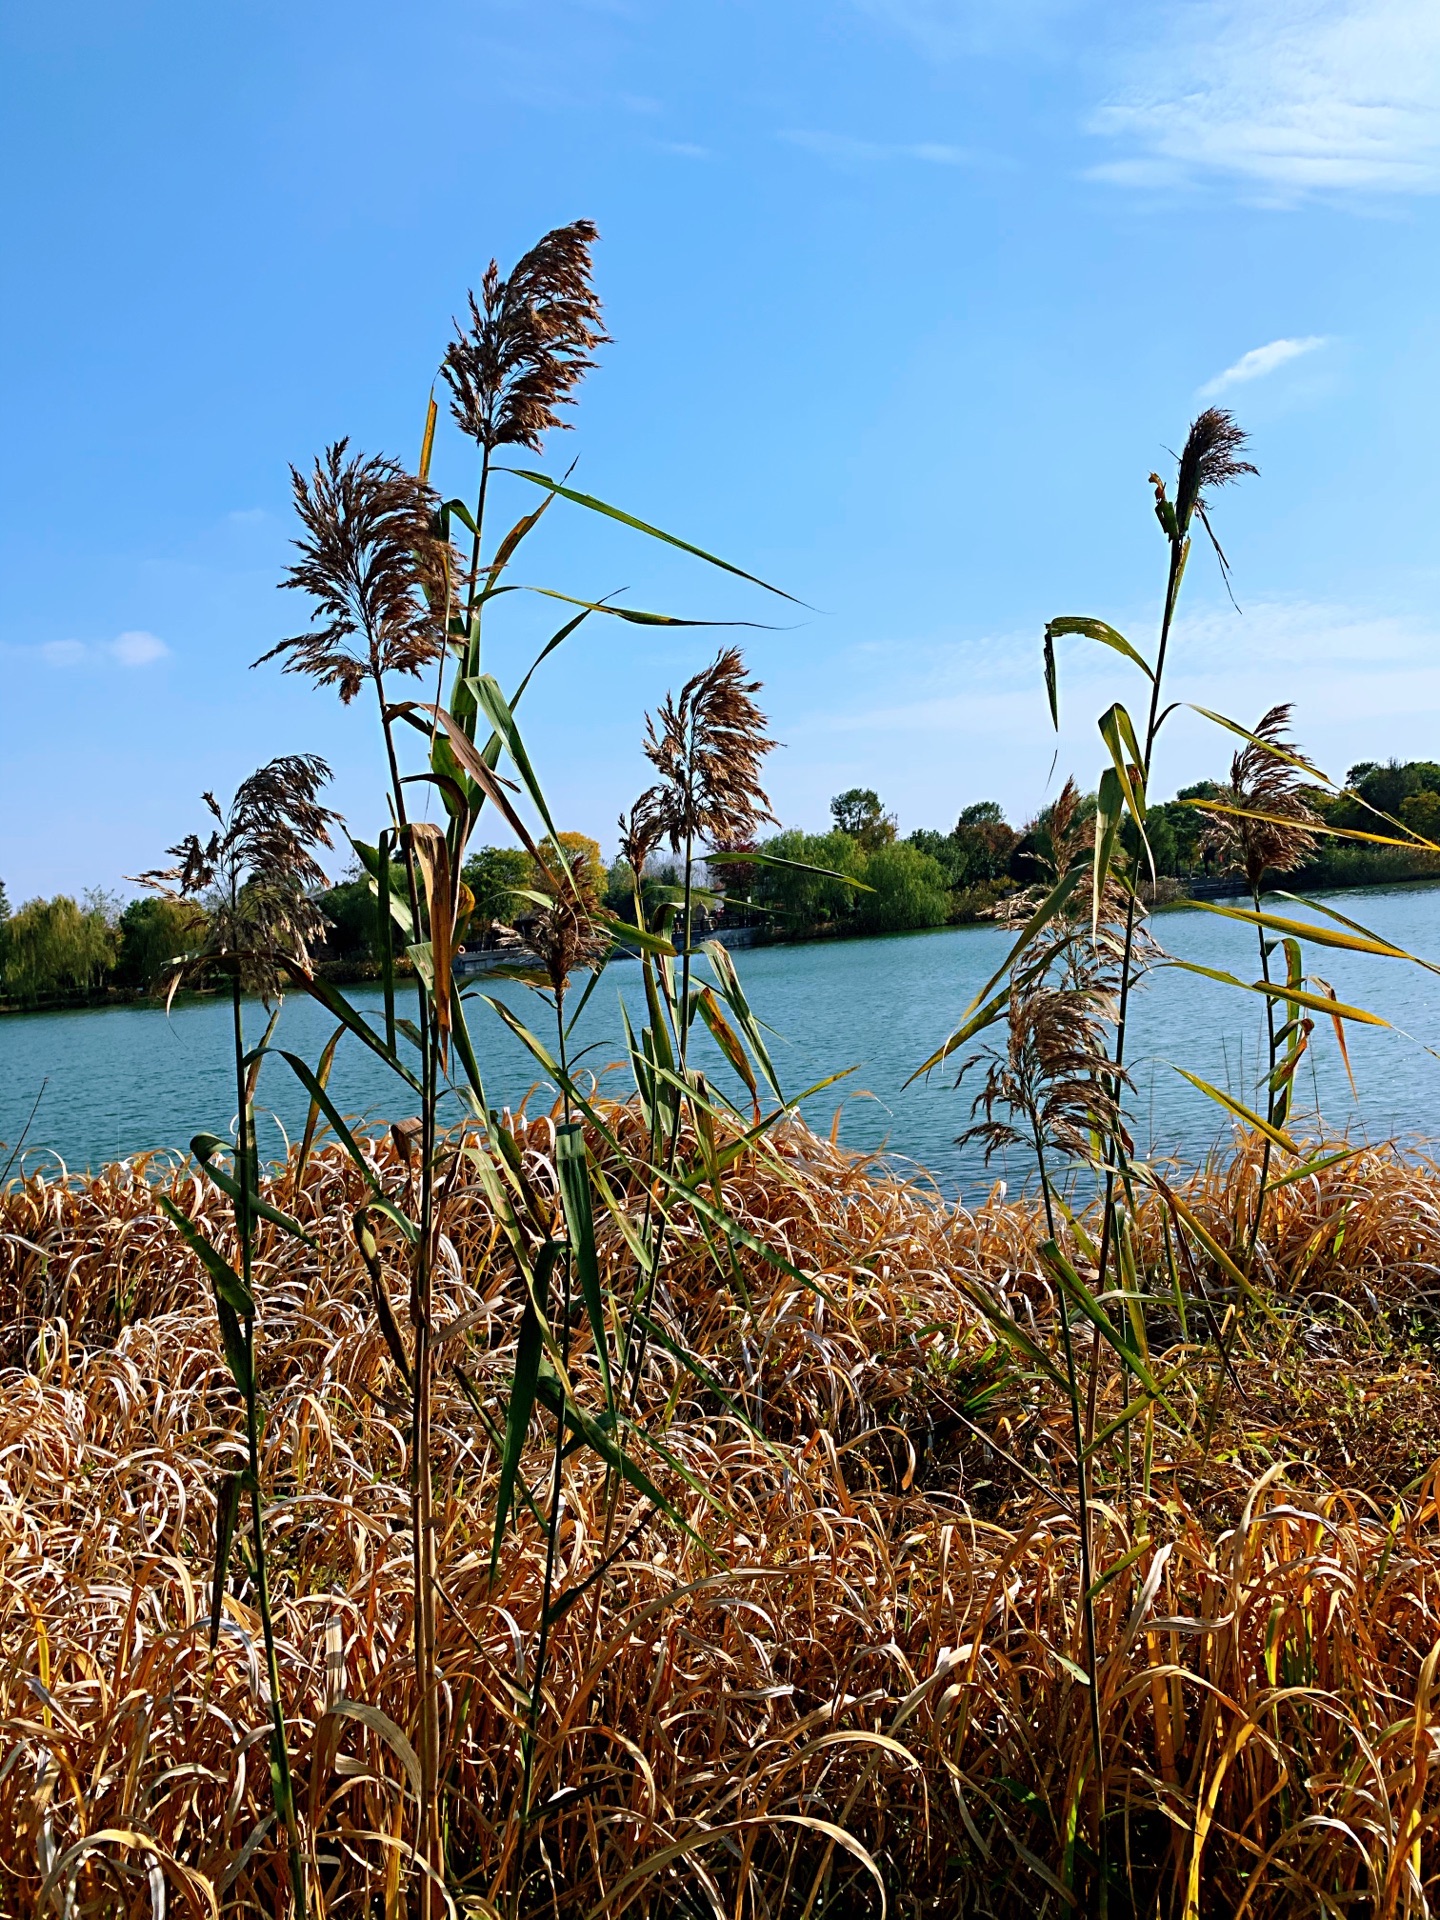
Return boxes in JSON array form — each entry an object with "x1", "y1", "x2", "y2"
[{"x1": 0, "y1": 0, "x2": 1440, "y2": 902}]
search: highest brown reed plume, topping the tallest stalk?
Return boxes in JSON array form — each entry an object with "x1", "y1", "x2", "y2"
[{"x1": 449, "y1": 221, "x2": 609, "y2": 455}]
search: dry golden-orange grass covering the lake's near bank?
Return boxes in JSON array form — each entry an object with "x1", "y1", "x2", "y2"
[{"x1": 0, "y1": 1108, "x2": 1440, "y2": 1920}]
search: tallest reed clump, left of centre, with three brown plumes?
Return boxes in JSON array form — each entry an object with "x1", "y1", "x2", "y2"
[{"x1": 247, "y1": 221, "x2": 802, "y2": 1920}]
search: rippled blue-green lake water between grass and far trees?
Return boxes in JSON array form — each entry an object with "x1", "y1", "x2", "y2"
[{"x1": 0, "y1": 885, "x2": 1440, "y2": 1198}]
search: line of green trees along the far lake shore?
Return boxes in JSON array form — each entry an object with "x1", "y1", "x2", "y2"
[{"x1": 0, "y1": 760, "x2": 1440, "y2": 1008}]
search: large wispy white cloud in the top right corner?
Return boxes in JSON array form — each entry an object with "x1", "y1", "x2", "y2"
[{"x1": 1091, "y1": 0, "x2": 1440, "y2": 204}]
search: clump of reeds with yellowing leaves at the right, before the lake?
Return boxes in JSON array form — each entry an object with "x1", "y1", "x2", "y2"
[{"x1": 918, "y1": 407, "x2": 1427, "y2": 1910}]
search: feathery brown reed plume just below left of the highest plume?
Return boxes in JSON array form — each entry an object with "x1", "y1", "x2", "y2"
[{"x1": 253, "y1": 440, "x2": 453, "y2": 703}]
